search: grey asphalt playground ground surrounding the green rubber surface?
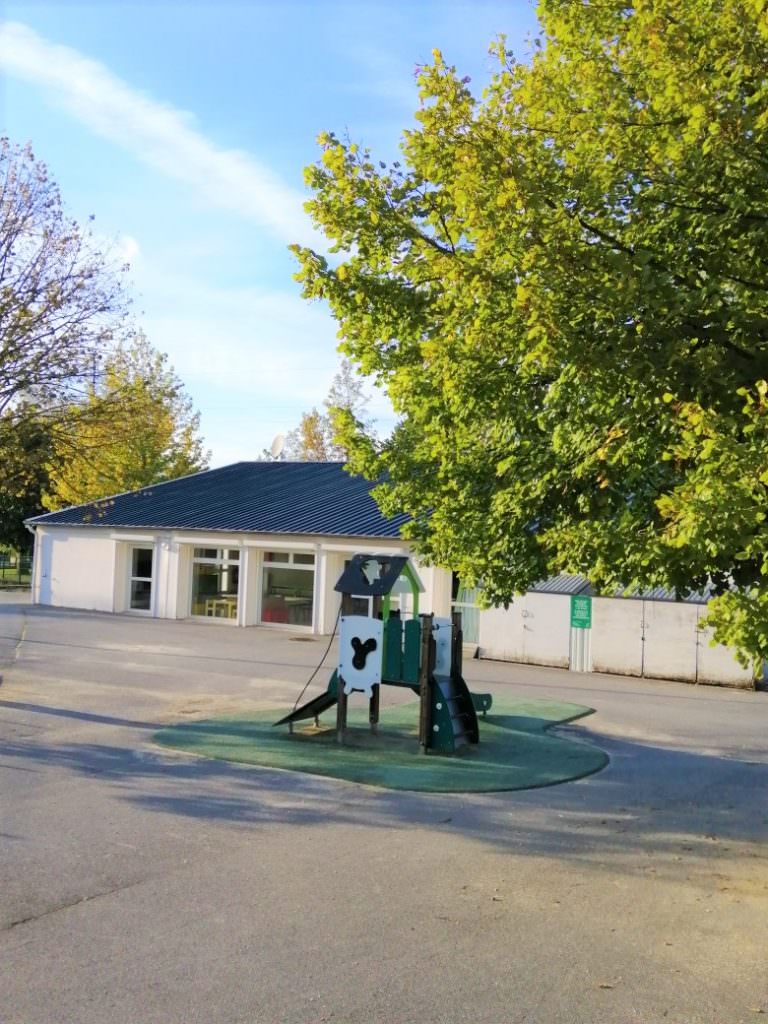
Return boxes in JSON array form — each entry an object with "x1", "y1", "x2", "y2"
[{"x1": 0, "y1": 594, "x2": 768, "y2": 1024}]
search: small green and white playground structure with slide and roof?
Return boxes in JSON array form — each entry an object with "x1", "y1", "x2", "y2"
[{"x1": 274, "y1": 554, "x2": 493, "y2": 754}]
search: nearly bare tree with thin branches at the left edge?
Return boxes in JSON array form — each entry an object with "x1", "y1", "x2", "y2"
[{"x1": 0, "y1": 138, "x2": 127, "y2": 548}]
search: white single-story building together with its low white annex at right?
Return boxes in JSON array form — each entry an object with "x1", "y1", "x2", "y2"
[{"x1": 28, "y1": 462, "x2": 752, "y2": 686}]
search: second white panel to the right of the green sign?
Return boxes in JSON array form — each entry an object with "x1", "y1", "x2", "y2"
[{"x1": 643, "y1": 601, "x2": 698, "y2": 683}]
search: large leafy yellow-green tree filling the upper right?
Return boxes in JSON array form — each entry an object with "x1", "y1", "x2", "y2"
[{"x1": 296, "y1": 0, "x2": 768, "y2": 657}]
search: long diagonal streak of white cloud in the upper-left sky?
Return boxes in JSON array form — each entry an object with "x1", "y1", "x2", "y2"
[{"x1": 0, "y1": 22, "x2": 318, "y2": 246}]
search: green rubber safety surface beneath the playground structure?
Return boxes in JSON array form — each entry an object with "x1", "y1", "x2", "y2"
[{"x1": 155, "y1": 698, "x2": 608, "y2": 793}]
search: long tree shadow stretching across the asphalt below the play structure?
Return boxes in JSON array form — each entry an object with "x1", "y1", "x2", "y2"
[{"x1": 0, "y1": 709, "x2": 768, "y2": 895}]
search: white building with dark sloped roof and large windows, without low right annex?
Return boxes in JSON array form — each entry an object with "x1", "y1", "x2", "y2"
[{"x1": 29, "y1": 462, "x2": 451, "y2": 634}]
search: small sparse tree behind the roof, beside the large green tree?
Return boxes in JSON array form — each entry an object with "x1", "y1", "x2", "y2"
[{"x1": 285, "y1": 358, "x2": 371, "y2": 462}]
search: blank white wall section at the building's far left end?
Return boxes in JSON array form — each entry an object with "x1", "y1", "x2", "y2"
[{"x1": 40, "y1": 527, "x2": 116, "y2": 611}]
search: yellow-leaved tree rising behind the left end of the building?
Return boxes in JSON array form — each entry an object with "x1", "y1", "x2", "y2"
[{"x1": 44, "y1": 335, "x2": 210, "y2": 509}]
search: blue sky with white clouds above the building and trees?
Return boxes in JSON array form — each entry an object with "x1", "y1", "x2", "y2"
[{"x1": 0, "y1": 0, "x2": 537, "y2": 466}]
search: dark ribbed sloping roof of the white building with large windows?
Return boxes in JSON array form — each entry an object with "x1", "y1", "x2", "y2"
[{"x1": 28, "y1": 462, "x2": 408, "y2": 537}]
